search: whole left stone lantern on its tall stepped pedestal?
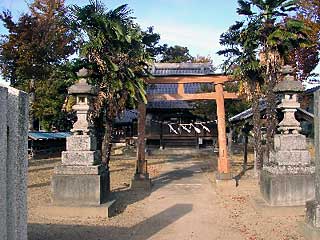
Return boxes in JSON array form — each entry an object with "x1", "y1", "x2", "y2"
[{"x1": 52, "y1": 69, "x2": 110, "y2": 206}]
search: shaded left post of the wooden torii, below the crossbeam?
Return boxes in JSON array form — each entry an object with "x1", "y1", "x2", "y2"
[{"x1": 131, "y1": 103, "x2": 151, "y2": 190}]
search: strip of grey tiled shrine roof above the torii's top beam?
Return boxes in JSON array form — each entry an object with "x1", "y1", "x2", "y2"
[{"x1": 151, "y1": 63, "x2": 214, "y2": 76}]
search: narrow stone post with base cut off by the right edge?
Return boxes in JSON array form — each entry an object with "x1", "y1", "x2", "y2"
[{"x1": 306, "y1": 90, "x2": 320, "y2": 234}]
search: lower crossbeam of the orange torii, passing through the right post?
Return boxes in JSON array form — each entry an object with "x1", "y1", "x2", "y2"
[{"x1": 147, "y1": 92, "x2": 238, "y2": 101}]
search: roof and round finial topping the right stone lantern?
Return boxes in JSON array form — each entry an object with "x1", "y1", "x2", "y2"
[{"x1": 273, "y1": 65, "x2": 304, "y2": 93}]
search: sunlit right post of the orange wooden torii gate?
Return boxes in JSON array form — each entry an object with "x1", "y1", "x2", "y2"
[{"x1": 215, "y1": 84, "x2": 232, "y2": 180}]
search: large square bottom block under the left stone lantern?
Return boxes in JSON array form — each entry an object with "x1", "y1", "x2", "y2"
[{"x1": 52, "y1": 166, "x2": 110, "y2": 206}]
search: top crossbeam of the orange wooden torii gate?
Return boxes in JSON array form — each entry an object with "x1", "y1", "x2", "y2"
[{"x1": 145, "y1": 75, "x2": 233, "y2": 84}]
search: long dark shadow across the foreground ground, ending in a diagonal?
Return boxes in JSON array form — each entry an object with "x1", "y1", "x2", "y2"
[{"x1": 28, "y1": 204, "x2": 193, "y2": 240}]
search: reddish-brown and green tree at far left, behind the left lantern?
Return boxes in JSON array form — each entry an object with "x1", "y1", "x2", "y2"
[{"x1": 0, "y1": 0, "x2": 77, "y2": 130}]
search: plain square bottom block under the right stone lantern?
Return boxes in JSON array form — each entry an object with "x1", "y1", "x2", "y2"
[{"x1": 260, "y1": 170, "x2": 315, "y2": 206}]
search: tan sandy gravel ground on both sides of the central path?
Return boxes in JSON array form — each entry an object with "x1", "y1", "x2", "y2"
[{"x1": 28, "y1": 152, "x2": 304, "y2": 240}]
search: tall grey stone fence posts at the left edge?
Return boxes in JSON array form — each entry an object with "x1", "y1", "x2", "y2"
[{"x1": 0, "y1": 85, "x2": 29, "y2": 240}]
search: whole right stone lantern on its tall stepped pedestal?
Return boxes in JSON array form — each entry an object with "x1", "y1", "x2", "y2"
[{"x1": 260, "y1": 66, "x2": 314, "y2": 206}]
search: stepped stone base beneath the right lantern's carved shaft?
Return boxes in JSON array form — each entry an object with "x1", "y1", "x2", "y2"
[{"x1": 260, "y1": 134, "x2": 315, "y2": 206}]
